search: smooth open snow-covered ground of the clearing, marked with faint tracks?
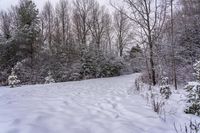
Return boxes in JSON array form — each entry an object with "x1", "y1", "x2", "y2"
[{"x1": 0, "y1": 74, "x2": 199, "y2": 133}]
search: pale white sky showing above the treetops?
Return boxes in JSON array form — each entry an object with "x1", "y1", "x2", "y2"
[{"x1": 0, "y1": 0, "x2": 109, "y2": 10}]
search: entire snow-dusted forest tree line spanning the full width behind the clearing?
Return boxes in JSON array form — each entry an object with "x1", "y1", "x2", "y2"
[{"x1": 0, "y1": 0, "x2": 200, "y2": 87}]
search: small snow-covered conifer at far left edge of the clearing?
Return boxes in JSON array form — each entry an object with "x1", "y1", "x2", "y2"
[{"x1": 8, "y1": 69, "x2": 20, "y2": 88}]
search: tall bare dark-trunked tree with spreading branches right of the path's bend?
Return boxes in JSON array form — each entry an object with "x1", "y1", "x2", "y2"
[{"x1": 113, "y1": 0, "x2": 167, "y2": 85}]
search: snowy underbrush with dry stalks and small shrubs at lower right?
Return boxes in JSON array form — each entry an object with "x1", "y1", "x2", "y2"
[{"x1": 134, "y1": 77, "x2": 200, "y2": 133}]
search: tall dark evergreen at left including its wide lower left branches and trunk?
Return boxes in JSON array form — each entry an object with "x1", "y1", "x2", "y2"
[{"x1": 7, "y1": 0, "x2": 39, "y2": 82}]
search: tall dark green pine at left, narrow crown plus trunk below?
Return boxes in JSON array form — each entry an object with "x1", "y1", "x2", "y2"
[{"x1": 14, "y1": 0, "x2": 40, "y2": 83}]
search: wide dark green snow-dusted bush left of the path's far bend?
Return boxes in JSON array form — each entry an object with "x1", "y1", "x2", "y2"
[{"x1": 80, "y1": 52, "x2": 123, "y2": 79}]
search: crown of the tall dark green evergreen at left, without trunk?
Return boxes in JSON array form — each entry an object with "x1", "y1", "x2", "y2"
[{"x1": 15, "y1": 0, "x2": 39, "y2": 59}]
